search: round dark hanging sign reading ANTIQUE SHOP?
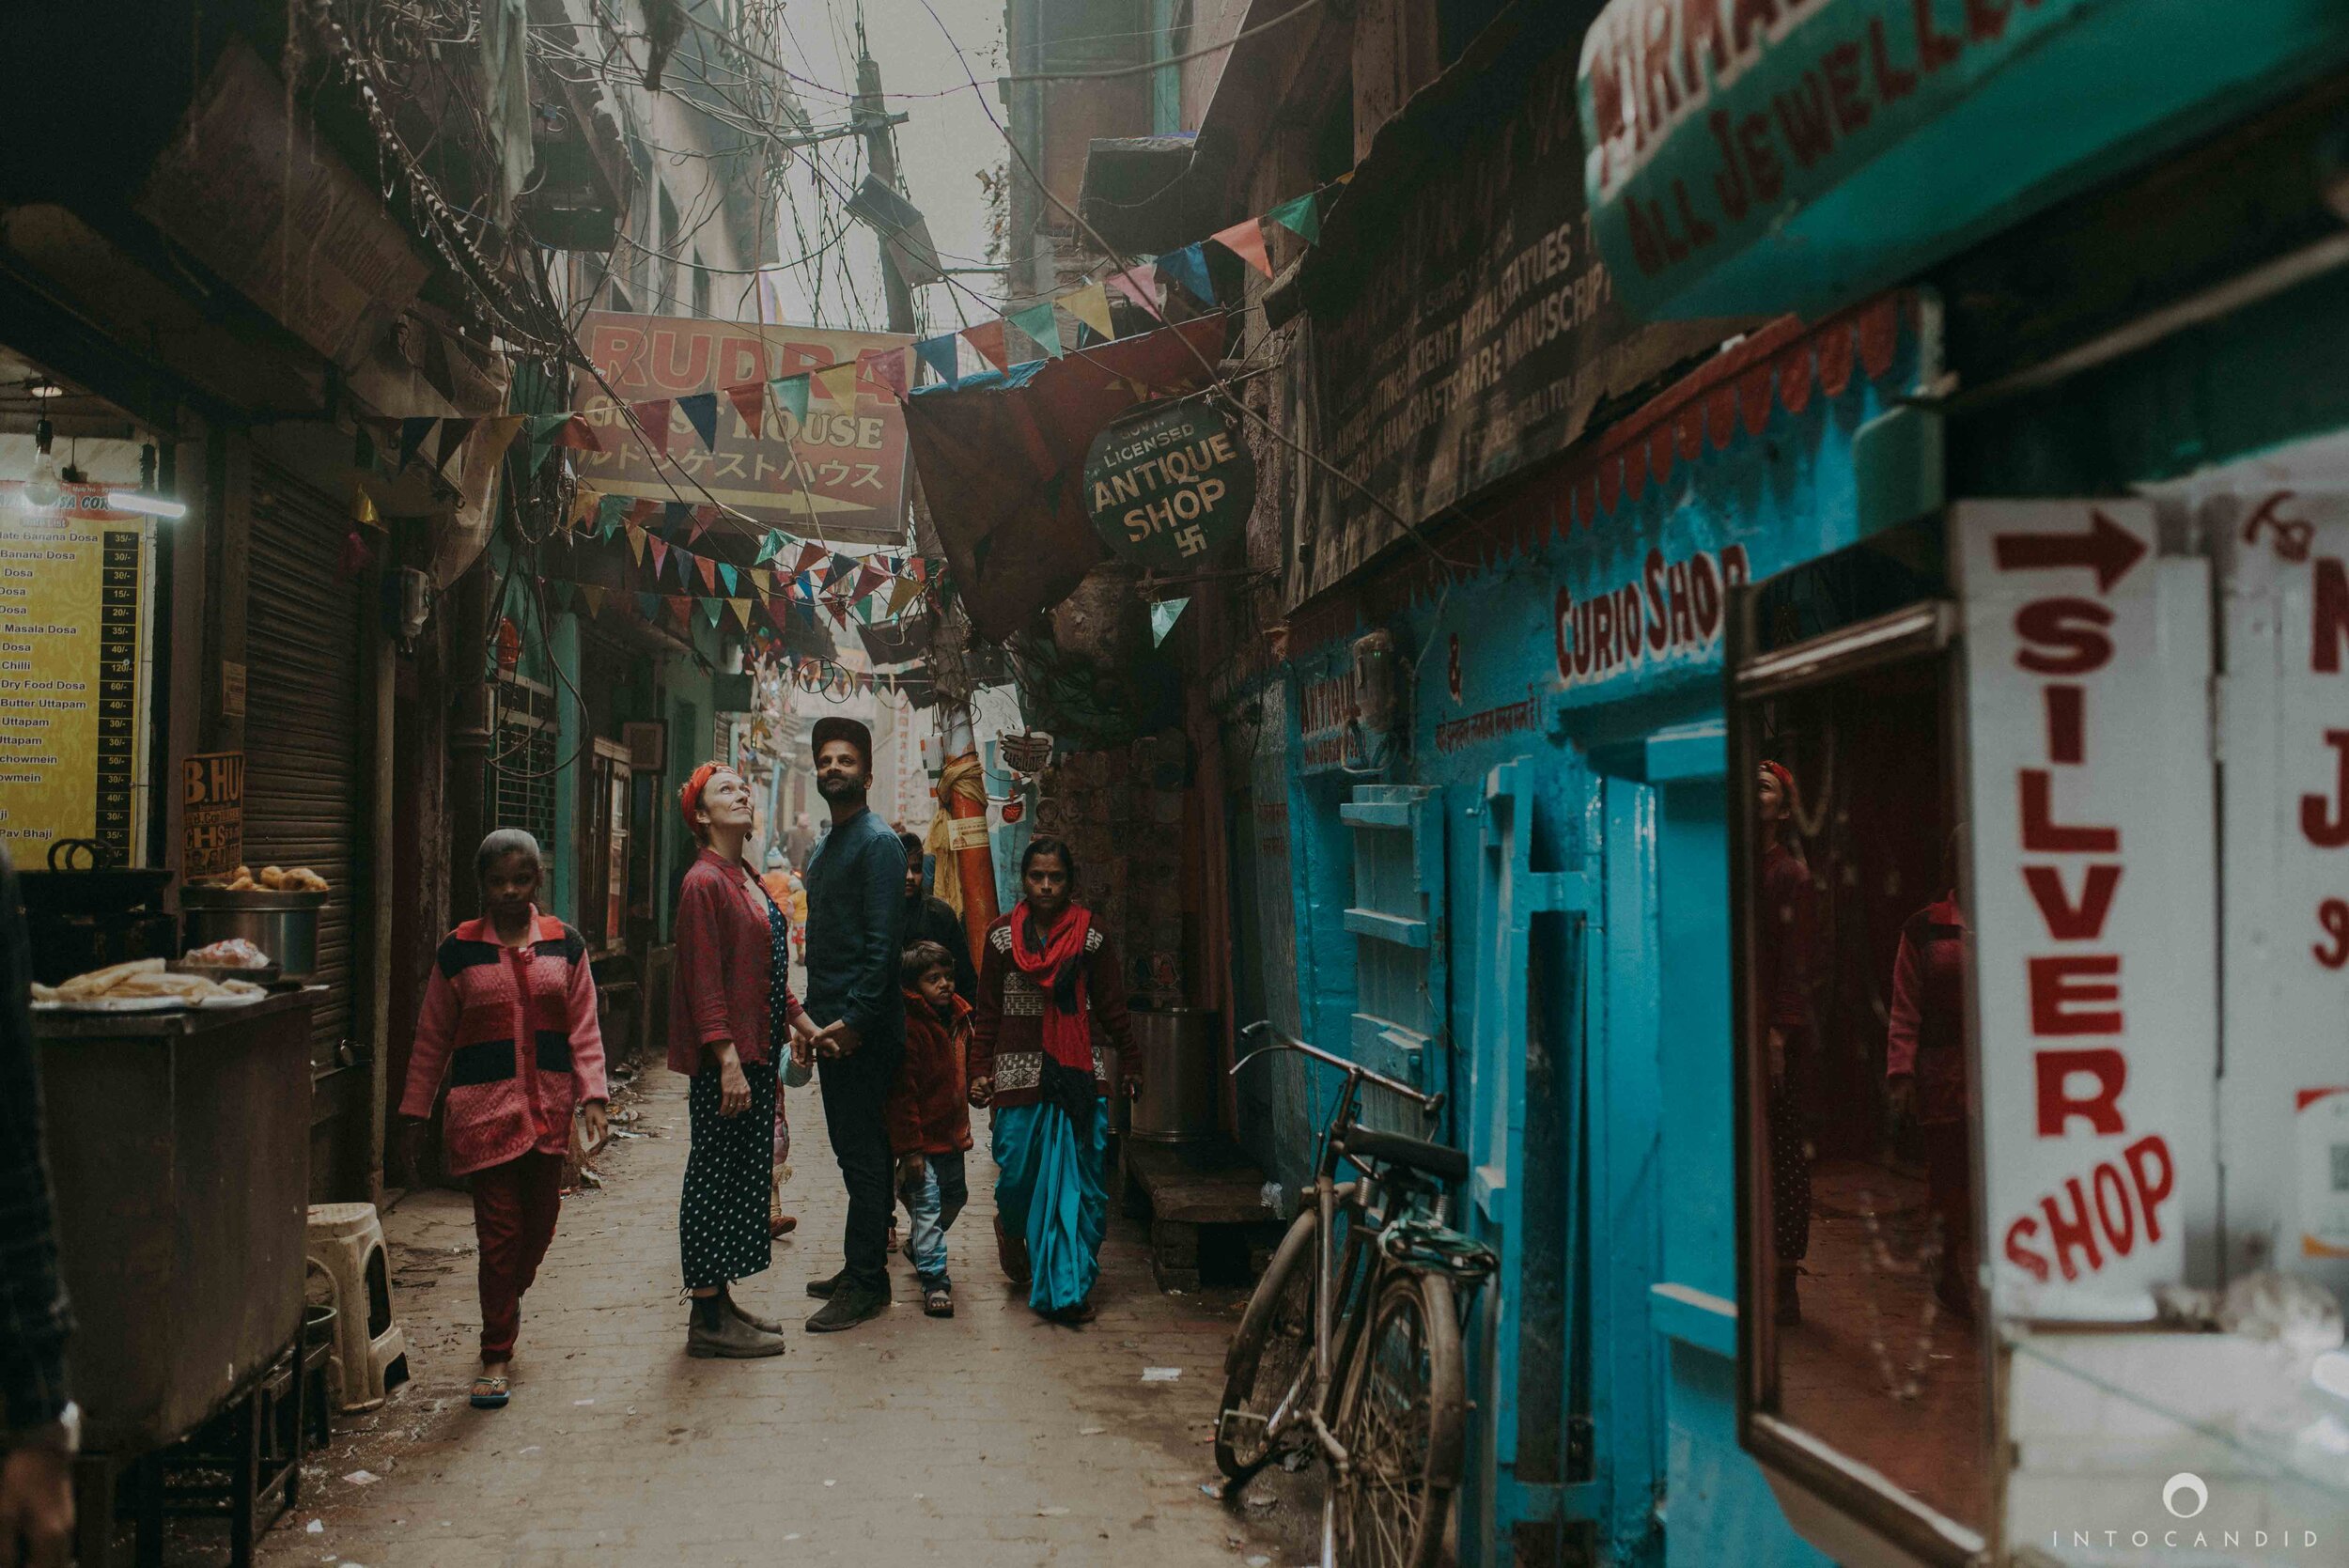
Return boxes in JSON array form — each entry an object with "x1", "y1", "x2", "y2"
[{"x1": 1085, "y1": 399, "x2": 1257, "y2": 570}]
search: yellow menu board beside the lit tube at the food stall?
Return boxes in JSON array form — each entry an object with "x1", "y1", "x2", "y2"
[{"x1": 0, "y1": 481, "x2": 148, "y2": 866}]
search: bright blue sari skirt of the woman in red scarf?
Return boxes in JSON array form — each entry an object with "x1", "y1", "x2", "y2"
[{"x1": 991, "y1": 1096, "x2": 1109, "y2": 1312}]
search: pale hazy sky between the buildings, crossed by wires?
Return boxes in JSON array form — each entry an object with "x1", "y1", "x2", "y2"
[{"x1": 756, "y1": 0, "x2": 1005, "y2": 331}]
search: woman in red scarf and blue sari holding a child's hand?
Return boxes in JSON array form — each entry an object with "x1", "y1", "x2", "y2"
[{"x1": 971, "y1": 838, "x2": 1137, "y2": 1324}]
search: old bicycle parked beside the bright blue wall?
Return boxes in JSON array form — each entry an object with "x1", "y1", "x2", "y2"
[{"x1": 1215, "y1": 1023, "x2": 1497, "y2": 1568}]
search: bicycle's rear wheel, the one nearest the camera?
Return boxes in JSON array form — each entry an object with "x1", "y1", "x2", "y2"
[{"x1": 1334, "y1": 1272, "x2": 1469, "y2": 1568}]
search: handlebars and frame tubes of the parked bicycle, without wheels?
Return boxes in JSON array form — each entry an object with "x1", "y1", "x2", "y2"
[{"x1": 1231, "y1": 1021, "x2": 1445, "y2": 1568}]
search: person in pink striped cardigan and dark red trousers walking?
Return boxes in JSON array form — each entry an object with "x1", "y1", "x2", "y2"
[{"x1": 399, "y1": 829, "x2": 609, "y2": 1411}]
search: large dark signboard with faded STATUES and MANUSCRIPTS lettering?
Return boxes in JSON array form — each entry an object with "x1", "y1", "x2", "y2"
[{"x1": 1306, "y1": 7, "x2": 1734, "y2": 564}]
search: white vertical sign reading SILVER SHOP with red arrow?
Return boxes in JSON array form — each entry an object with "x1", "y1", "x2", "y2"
[{"x1": 1952, "y1": 500, "x2": 2217, "y2": 1319}]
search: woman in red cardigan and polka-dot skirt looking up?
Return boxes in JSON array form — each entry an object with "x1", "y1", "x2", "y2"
[{"x1": 670, "y1": 763, "x2": 816, "y2": 1359}]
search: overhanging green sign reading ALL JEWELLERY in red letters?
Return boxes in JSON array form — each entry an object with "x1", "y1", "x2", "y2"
[{"x1": 1579, "y1": 0, "x2": 2349, "y2": 317}]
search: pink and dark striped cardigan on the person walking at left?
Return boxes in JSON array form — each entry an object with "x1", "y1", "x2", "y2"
[{"x1": 399, "y1": 908, "x2": 609, "y2": 1176}]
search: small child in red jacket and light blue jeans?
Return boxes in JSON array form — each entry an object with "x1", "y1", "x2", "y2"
[{"x1": 888, "y1": 941, "x2": 971, "y2": 1317}]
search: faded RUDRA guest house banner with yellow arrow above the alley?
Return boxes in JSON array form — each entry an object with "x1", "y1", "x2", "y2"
[{"x1": 578, "y1": 310, "x2": 911, "y2": 545}]
